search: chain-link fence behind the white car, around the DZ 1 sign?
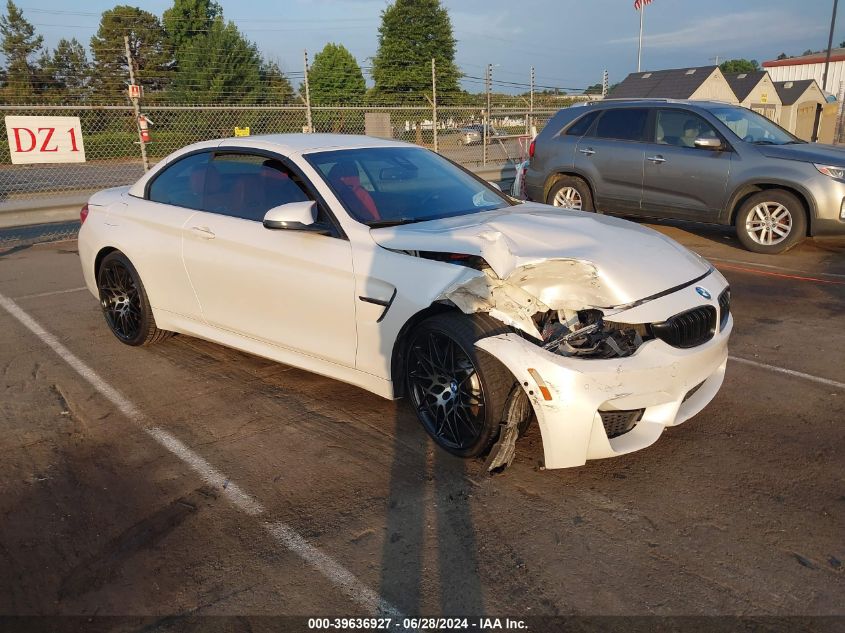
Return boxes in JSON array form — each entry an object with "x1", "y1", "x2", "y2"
[{"x1": 0, "y1": 103, "x2": 568, "y2": 211}]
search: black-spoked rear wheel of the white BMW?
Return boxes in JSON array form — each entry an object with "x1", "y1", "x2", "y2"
[{"x1": 97, "y1": 251, "x2": 172, "y2": 346}]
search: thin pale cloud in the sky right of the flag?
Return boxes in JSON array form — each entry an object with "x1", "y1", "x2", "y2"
[{"x1": 609, "y1": 10, "x2": 826, "y2": 49}]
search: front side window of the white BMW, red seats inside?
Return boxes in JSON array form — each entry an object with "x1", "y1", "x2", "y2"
[{"x1": 202, "y1": 153, "x2": 314, "y2": 222}]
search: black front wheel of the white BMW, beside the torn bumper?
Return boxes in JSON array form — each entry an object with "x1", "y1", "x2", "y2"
[{"x1": 405, "y1": 312, "x2": 516, "y2": 457}]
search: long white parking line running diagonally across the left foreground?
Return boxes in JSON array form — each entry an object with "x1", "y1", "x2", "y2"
[{"x1": 0, "y1": 294, "x2": 403, "y2": 618}]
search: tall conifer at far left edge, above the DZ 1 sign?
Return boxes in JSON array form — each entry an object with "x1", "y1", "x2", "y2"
[{"x1": 0, "y1": 0, "x2": 44, "y2": 97}]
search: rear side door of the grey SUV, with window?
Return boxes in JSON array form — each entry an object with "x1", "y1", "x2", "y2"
[{"x1": 575, "y1": 108, "x2": 649, "y2": 213}]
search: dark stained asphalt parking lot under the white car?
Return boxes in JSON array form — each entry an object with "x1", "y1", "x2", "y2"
[{"x1": 0, "y1": 223, "x2": 845, "y2": 631}]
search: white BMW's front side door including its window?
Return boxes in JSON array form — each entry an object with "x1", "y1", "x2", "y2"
[{"x1": 183, "y1": 150, "x2": 357, "y2": 366}]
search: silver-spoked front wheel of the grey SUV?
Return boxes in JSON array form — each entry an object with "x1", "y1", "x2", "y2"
[{"x1": 736, "y1": 189, "x2": 807, "y2": 255}]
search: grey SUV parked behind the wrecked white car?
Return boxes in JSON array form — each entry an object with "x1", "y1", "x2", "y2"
[{"x1": 525, "y1": 99, "x2": 845, "y2": 253}]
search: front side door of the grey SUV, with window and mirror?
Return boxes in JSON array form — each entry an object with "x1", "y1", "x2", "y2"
[{"x1": 642, "y1": 108, "x2": 733, "y2": 221}]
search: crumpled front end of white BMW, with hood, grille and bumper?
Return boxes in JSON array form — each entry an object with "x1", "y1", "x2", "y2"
[{"x1": 371, "y1": 204, "x2": 733, "y2": 470}]
